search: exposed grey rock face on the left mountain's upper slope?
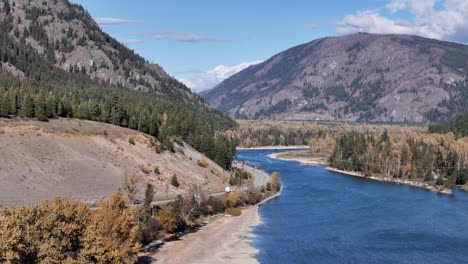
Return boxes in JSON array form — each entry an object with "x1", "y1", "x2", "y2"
[{"x1": 0, "y1": 0, "x2": 194, "y2": 101}]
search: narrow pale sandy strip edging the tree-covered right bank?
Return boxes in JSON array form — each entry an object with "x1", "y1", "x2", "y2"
[{"x1": 268, "y1": 151, "x2": 453, "y2": 195}]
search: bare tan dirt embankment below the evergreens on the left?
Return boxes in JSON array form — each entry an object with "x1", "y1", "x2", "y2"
[{"x1": 0, "y1": 118, "x2": 229, "y2": 205}]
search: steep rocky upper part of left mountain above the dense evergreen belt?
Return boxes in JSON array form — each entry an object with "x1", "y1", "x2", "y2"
[{"x1": 0, "y1": 0, "x2": 234, "y2": 119}]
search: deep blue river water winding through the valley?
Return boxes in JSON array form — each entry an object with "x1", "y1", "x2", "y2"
[{"x1": 237, "y1": 150, "x2": 468, "y2": 264}]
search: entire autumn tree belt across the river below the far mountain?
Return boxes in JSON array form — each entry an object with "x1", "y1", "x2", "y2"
[{"x1": 230, "y1": 119, "x2": 468, "y2": 188}]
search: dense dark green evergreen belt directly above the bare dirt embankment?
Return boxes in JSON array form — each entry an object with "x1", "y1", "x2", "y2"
[{"x1": 0, "y1": 77, "x2": 236, "y2": 169}]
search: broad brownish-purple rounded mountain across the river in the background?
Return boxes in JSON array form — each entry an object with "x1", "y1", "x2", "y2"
[{"x1": 202, "y1": 33, "x2": 468, "y2": 123}]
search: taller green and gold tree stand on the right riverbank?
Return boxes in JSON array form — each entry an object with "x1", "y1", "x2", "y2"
[{"x1": 329, "y1": 131, "x2": 468, "y2": 189}]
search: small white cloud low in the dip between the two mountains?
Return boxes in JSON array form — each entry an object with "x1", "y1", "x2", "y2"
[{"x1": 180, "y1": 61, "x2": 262, "y2": 92}]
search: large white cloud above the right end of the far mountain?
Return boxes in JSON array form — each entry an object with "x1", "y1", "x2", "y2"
[{"x1": 337, "y1": 0, "x2": 468, "y2": 42}]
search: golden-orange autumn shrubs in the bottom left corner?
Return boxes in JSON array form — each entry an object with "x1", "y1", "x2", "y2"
[{"x1": 0, "y1": 194, "x2": 140, "y2": 263}]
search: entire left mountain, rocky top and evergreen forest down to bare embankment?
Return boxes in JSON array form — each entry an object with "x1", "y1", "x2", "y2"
[{"x1": 0, "y1": 0, "x2": 236, "y2": 169}]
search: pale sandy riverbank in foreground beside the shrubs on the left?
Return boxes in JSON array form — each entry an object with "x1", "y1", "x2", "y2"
[{"x1": 151, "y1": 191, "x2": 281, "y2": 264}]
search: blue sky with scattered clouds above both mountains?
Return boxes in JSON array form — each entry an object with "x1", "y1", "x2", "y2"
[{"x1": 73, "y1": 0, "x2": 468, "y2": 91}]
